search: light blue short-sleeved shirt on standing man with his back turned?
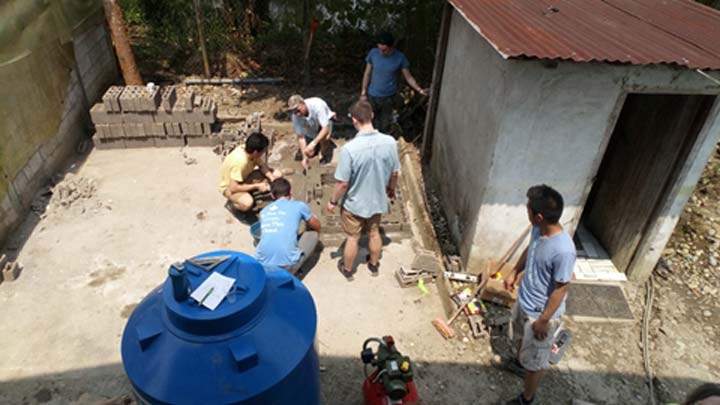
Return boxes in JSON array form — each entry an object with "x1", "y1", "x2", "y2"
[{"x1": 339, "y1": 131, "x2": 399, "y2": 218}]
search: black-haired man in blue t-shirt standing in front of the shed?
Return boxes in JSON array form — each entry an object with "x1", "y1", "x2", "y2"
[{"x1": 498, "y1": 184, "x2": 576, "y2": 405}]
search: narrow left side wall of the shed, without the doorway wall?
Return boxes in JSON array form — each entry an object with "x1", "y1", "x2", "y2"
[{"x1": 432, "y1": 11, "x2": 507, "y2": 266}]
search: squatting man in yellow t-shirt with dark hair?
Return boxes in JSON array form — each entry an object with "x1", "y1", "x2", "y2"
[{"x1": 220, "y1": 132, "x2": 282, "y2": 212}]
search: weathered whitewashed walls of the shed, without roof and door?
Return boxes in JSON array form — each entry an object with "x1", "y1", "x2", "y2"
[{"x1": 431, "y1": 14, "x2": 720, "y2": 278}]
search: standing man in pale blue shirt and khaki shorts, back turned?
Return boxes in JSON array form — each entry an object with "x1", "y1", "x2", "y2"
[{"x1": 327, "y1": 100, "x2": 400, "y2": 281}]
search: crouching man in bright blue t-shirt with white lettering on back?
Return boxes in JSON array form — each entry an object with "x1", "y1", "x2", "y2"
[{"x1": 255, "y1": 178, "x2": 320, "y2": 274}]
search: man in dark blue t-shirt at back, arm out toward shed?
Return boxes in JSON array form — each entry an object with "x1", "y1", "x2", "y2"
[{"x1": 360, "y1": 32, "x2": 427, "y2": 134}]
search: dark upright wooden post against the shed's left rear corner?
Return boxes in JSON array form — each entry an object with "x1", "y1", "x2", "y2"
[{"x1": 421, "y1": 2, "x2": 453, "y2": 163}]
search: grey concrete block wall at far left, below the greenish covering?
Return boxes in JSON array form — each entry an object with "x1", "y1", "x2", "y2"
[{"x1": 0, "y1": 24, "x2": 118, "y2": 245}]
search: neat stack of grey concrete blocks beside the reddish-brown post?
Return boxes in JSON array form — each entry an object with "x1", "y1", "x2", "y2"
[{"x1": 90, "y1": 86, "x2": 220, "y2": 149}]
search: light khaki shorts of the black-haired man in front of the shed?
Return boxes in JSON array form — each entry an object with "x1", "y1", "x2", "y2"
[{"x1": 510, "y1": 303, "x2": 560, "y2": 371}]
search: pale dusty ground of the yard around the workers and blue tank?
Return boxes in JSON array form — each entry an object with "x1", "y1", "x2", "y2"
[{"x1": 0, "y1": 83, "x2": 720, "y2": 405}]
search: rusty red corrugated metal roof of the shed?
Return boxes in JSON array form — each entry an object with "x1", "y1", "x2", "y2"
[{"x1": 449, "y1": 0, "x2": 720, "y2": 69}]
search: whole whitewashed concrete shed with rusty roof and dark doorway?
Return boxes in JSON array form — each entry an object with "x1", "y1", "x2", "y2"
[{"x1": 423, "y1": 0, "x2": 720, "y2": 280}]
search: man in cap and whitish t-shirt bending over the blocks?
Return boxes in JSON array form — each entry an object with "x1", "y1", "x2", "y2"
[{"x1": 288, "y1": 94, "x2": 335, "y2": 168}]
